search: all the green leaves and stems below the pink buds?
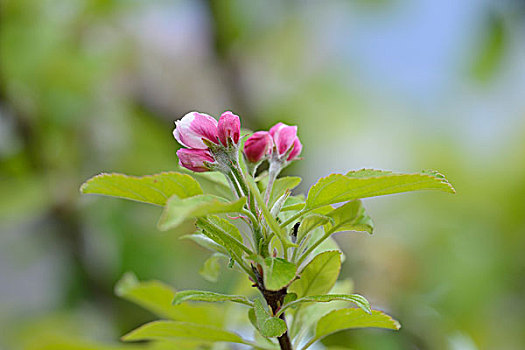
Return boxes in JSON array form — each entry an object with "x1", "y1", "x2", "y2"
[{"x1": 82, "y1": 160, "x2": 454, "y2": 349}]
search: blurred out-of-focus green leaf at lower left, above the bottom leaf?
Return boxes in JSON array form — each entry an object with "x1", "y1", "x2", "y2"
[{"x1": 115, "y1": 273, "x2": 224, "y2": 325}]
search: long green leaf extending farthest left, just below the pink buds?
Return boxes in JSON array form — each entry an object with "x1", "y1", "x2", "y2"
[{"x1": 80, "y1": 171, "x2": 203, "y2": 206}]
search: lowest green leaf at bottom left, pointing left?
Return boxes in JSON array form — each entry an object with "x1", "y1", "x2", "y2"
[{"x1": 122, "y1": 321, "x2": 250, "y2": 344}]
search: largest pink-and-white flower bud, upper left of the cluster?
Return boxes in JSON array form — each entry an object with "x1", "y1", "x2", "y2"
[{"x1": 173, "y1": 112, "x2": 219, "y2": 149}]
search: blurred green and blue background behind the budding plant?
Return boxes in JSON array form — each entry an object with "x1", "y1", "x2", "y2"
[{"x1": 0, "y1": 0, "x2": 525, "y2": 350}]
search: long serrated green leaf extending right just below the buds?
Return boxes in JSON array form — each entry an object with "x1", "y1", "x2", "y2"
[{"x1": 305, "y1": 169, "x2": 455, "y2": 210}]
